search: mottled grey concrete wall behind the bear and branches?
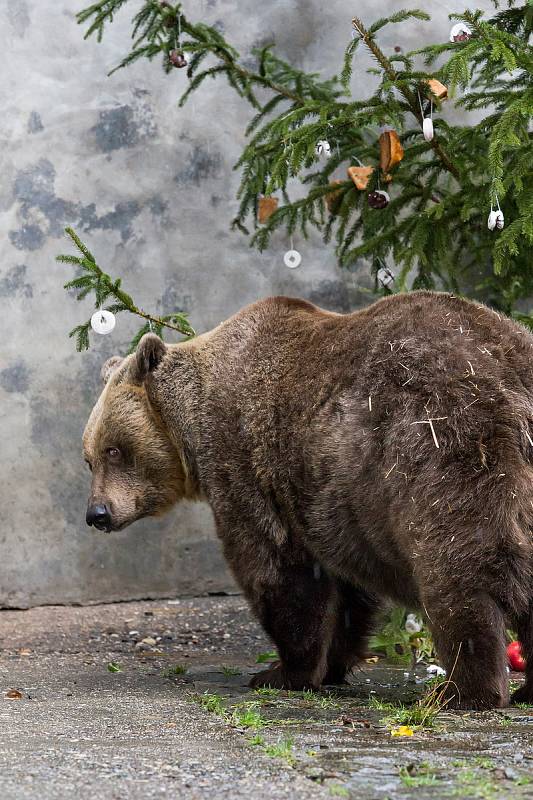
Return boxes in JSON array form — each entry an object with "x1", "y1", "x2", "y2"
[{"x1": 0, "y1": 0, "x2": 490, "y2": 606}]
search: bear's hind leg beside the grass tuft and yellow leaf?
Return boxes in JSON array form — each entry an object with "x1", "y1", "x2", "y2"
[{"x1": 424, "y1": 587, "x2": 509, "y2": 710}]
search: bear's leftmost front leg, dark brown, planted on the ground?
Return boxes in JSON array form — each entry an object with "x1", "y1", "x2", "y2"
[{"x1": 248, "y1": 563, "x2": 337, "y2": 690}]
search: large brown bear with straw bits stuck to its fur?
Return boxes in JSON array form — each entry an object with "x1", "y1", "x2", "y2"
[{"x1": 84, "y1": 292, "x2": 533, "y2": 709}]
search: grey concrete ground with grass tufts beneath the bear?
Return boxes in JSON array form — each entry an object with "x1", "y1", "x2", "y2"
[{"x1": 0, "y1": 597, "x2": 533, "y2": 800}]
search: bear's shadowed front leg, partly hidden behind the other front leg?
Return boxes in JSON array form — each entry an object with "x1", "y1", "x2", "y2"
[{"x1": 324, "y1": 580, "x2": 378, "y2": 684}]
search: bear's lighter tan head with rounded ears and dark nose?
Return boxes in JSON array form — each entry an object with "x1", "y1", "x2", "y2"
[{"x1": 83, "y1": 334, "x2": 190, "y2": 532}]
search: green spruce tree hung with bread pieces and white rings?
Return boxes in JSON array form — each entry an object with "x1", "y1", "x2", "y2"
[{"x1": 59, "y1": 0, "x2": 533, "y2": 347}]
